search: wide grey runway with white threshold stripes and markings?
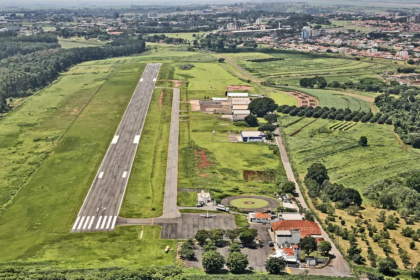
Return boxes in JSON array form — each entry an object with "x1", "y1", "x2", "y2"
[{"x1": 71, "y1": 63, "x2": 161, "y2": 232}]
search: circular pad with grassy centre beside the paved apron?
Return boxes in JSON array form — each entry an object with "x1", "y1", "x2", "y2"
[{"x1": 222, "y1": 195, "x2": 280, "y2": 212}]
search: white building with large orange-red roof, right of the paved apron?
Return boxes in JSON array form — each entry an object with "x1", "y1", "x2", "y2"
[{"x1": 271, "y1": 220, "x2": 322, "y2": 246}]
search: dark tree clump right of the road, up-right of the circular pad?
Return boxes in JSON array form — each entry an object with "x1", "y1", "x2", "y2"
[{"x1": 304, "y1": 163, "x2": 363, "y2": 208}]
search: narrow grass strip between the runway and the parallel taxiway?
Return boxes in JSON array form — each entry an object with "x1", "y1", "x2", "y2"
[{"x1": 120, "y1": 89, "x2": 173, "y2": 218}]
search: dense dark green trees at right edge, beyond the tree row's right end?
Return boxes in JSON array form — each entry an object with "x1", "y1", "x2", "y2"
[{"x1": 375, "y1": 93, "x2": 420, "y2": 148}]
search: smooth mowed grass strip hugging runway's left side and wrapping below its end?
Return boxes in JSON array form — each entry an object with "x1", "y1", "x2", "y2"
[{"x1": 0, "y1": 61, "x2": 175, "y2": 268}]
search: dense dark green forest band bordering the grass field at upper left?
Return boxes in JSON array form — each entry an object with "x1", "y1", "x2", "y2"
[{"x1": 0, "y1": 35, "x2": 145, "y2": 112}]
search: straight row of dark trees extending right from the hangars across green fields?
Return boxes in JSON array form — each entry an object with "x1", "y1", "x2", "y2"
[{"x1": 277, "y1": 105, "x2": 392, "y2": 125}]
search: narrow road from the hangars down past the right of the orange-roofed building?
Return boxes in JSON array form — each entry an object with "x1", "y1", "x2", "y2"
[{"x1": 274, "y1": 128, "x2": 351, "y2": 276}]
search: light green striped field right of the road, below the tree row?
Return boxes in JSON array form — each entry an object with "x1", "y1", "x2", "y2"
[{"x1": 280, "y1": 114, "x2": 420, "y2": 197}]
